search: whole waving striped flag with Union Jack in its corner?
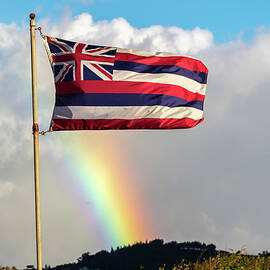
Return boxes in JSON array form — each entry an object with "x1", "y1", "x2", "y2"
[{"x1": 44, "y1": 36, "x2": 208, "y2": 131}]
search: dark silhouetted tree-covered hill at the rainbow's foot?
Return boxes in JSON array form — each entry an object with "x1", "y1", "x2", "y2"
[{"x1": 51, "y1": 239, "x2": 217, "y2": 270}]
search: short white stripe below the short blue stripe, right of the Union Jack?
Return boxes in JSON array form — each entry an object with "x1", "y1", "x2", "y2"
[{"x1": 113, "y1": 70, "x2": 206, "y2": 95}]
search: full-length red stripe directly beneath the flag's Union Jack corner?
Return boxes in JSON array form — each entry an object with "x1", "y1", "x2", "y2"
[{"x1": 55, "y1": 80, "x2": 205, "y2": 101}]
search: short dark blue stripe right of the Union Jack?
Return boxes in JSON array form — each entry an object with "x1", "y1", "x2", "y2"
[{"x1": 114, "y1": 60, "x2": 207, "y2": 84}]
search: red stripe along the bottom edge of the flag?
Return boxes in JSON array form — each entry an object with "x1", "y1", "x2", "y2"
[{"x1": 52, "y1": 118, "x2": 204, "y2": 131}]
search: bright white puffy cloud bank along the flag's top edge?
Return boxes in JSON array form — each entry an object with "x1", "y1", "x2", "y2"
[{"x1": 40, "y1": 13, "x2": 213, "y2": 54}]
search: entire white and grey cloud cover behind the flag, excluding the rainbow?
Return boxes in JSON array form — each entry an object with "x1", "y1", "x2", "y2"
[{"x1": 0, "y1": 13, "x2": 270, "y2": 267}]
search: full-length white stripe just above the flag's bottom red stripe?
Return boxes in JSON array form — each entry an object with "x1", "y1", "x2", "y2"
[{"x1": 53, "y1": 105, "x2": 203, "y2": 120}]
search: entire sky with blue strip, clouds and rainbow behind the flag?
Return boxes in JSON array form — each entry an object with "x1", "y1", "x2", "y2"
[{"x1": 0, "y1": 0, "x2": 270, "y2": 268}]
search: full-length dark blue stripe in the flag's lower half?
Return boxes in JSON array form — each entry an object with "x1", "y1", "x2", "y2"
[{"x1": 55, "y1": 93, "x2": 203, "y2": 110}]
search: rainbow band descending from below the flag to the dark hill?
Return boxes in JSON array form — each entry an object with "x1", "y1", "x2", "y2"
[{"x1": 53, "y1": 132, "x2": 154, "y2": 247}]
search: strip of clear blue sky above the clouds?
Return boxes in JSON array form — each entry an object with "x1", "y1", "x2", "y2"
[{"x1": 1, "y1": 0, "x2": 270, "y2": 43}]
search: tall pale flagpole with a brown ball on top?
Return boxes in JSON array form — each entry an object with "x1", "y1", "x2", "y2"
[{"x1": 30, "y1": 13, "x2": 42, "y2": 270}]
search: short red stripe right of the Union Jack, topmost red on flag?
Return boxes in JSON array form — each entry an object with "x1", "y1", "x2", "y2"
[{"x1": 115, "y1": 52, "x2": 208, "y2": 73}]
